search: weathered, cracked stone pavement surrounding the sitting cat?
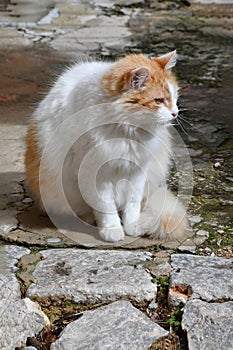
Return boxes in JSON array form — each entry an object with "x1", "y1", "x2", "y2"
[{"x1": 0, "y1": 0, "x2": 233, "y2": 350}]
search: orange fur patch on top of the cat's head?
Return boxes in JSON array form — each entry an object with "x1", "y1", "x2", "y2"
[{"x1": 102, "y1": 55, "x2": 177, "y2": 110}]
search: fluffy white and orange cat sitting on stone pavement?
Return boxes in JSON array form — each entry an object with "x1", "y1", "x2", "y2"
[{"x1": 25, "y1": 51, "x2": 187, "y2": 242}]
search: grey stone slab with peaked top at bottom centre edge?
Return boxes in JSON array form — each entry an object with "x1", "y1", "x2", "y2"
[{"x1": 52, "y1": 300, "x2": 168, "y2": 350}]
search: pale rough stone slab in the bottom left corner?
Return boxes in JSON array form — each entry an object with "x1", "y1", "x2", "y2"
[{"x1": 0, "y1": 298, "x2": 49, "y2": 350}]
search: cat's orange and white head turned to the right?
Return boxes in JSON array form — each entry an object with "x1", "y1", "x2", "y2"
[{"x1": 103, "y1": 51, "x2": 178, "y2": 124}]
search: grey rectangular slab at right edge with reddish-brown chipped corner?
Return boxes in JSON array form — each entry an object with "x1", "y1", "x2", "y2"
[{"x1": 169, "y1": 254, "x2": 233, "y2": 304}]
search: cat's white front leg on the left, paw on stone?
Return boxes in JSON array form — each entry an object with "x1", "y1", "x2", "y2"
[{"x1": 93, "y1": 185, "x2": 125, "y2": 242}]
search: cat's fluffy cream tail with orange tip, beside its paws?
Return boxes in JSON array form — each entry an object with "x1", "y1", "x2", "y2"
[{"x1": 138, "y1": 186, "x2": 191, "y2": 241}]
